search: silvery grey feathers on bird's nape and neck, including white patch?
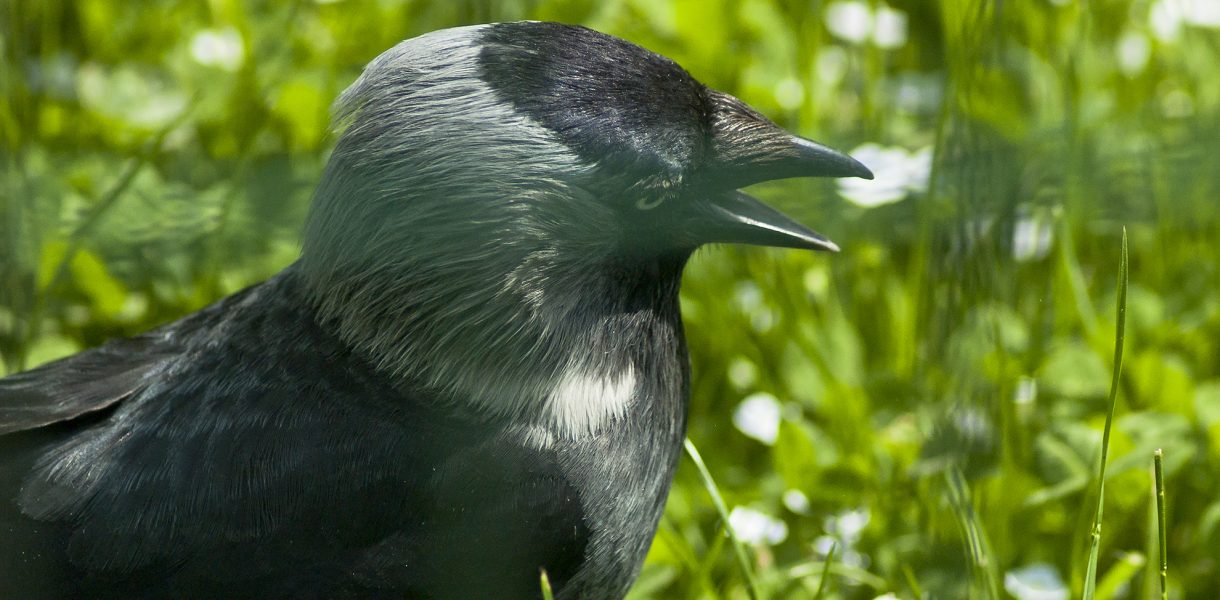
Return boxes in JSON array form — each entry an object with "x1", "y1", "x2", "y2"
[{"x1": 301, "y1": 28, "x2": 686, "y2": 435}]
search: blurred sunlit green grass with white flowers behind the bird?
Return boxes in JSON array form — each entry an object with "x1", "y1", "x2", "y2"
[{"x1": 0, "y1": 0, "x2": 1220, "y2": 600}]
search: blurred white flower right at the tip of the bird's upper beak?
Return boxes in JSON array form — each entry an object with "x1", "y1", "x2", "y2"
[{"x1": 838, "y1": 144, "x2": 932, "y2": 209}]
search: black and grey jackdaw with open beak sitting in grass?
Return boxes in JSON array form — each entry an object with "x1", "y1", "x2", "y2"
[{"x1": 0, "y1": 22, "x2": 871, "y2": 599}]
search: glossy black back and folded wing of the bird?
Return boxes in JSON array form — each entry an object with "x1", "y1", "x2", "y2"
[{"x1": 0, "y1": 270, "x2": 619, "y2": 598}]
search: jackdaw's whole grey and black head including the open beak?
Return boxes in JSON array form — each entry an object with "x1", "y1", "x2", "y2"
[{"x1": 303, "y1": 22, "x2": 872, "y2": 424}]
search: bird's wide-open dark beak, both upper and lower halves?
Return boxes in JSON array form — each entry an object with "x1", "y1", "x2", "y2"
[{"x1": 693, "y1": 91, "x2": 872, "y2": 251}]
